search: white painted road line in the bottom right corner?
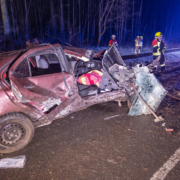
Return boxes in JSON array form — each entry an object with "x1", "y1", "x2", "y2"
[{"x1": 150, "y1": 148, "x2": 180, "y2": 180}]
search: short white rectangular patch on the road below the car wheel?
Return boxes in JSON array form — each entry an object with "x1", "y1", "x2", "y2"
[{"x1": 0, "y1": 155, "x2": 26, "y2": 169}]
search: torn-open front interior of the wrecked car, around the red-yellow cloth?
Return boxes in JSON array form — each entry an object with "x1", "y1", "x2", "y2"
[{"x1": 67, "y1": 48, "x2": 124, "y2": 97}]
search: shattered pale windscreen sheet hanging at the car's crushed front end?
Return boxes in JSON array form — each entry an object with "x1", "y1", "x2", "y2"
[{"x1": 128, "y1": 66, "x2": 167, "y2": 116}]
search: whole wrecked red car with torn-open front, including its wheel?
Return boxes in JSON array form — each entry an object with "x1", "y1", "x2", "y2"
[{"x1": 0, "y1": 44, "x2": 166, "y2": 153}]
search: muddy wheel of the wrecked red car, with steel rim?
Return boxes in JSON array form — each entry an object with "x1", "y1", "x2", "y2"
[{"x1": 0, "y1": 113, "x2": 34, "y2": 154}]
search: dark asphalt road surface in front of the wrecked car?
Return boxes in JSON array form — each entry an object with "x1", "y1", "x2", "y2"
[{"x1": 0, "y1": 71, "x2": 180, "y2": 180}]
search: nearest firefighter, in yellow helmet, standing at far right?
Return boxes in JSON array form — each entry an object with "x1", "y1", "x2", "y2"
[{"x1": 152, "y1": 32, "x2": 166, "y2": 72}]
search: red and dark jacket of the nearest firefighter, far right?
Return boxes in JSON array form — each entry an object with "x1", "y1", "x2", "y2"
[{"x1": 152, "y1": 39, "x2": 166, "y2": 56}]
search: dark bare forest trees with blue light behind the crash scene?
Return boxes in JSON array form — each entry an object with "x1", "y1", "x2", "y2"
[{"x1": 0, "y1": 0, "x2": 180, "y2": 49}]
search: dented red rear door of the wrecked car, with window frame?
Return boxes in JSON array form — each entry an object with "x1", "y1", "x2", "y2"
[{"x1": 9, "y1": 45, "x2": 74, "y2": 116}]
